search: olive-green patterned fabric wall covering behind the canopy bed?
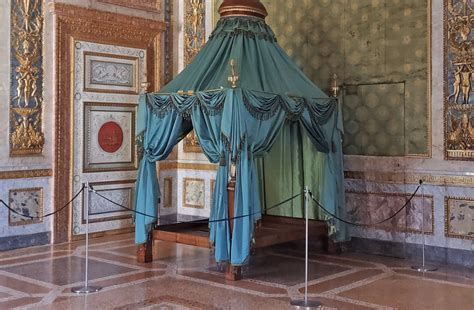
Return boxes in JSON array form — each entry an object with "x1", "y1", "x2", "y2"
[{"x1": 215, "y1": 0, "x2": 430, "y2": 156}]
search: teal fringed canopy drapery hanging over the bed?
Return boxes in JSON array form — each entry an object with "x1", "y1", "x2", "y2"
[{"x1": 135, "y1": 17, "x2": 346, "y2": 265}]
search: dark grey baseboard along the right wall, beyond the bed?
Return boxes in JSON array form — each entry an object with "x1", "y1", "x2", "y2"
[{"x1": 348, "y1": 237, "x2": 474, "y2": 268}]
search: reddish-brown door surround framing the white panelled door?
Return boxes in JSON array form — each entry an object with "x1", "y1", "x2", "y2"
[{"x1": 50, "y1": 2, "x2": 166, "y2": 243}]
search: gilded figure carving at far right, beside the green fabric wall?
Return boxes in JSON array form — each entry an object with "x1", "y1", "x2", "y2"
[{"x1": 444, "y1": 0, "x2": 474, "y2": 160}]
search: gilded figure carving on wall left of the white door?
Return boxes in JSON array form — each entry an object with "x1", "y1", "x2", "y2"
[{"x1": 10, "y1": 0, "x2": 44, "y2": 156}]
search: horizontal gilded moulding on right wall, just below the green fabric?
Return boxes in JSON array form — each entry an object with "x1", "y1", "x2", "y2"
[{"x1": 344, "y1": 171, "x2": 474, "y2": 186}]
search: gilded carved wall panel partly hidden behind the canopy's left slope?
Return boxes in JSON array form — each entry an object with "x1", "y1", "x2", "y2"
[{"x1": 183, "y1": 0, "x2": 206, "y2": 153}]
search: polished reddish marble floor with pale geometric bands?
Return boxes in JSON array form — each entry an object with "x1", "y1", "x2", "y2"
[{"x1": 0, "y1": 235, "x2": 474, "y2": 310}]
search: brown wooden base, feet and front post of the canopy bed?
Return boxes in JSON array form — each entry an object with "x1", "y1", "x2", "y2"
[{"x1": 137, "y1": 180, "x2": 330, "y2": 281}]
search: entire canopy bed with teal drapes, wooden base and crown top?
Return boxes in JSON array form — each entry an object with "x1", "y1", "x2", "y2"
[{"x1": 135, "y1": 0, "x2": 346, "y2": 279}]
